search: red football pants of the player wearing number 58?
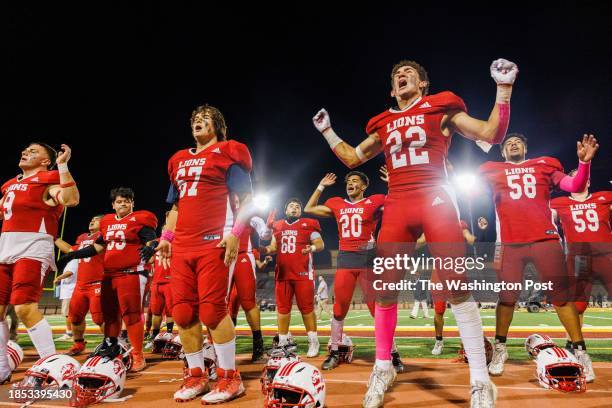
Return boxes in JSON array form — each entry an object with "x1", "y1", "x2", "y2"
[{"x1": 497, "y1": 239, "x2": 573, "y2": 305}]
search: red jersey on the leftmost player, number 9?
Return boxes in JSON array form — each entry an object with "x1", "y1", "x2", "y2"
[{"x1": 2, "y1": 170, "x2": 64, "y2": 237}]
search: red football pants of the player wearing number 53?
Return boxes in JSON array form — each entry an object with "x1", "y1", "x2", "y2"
[{"x1": 102, "y1": 273, "x2": 148, "y2": 326}]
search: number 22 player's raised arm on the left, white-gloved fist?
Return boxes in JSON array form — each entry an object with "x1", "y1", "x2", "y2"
[{"x1": 312, "y1": 109, "x2": 383, "y2": 169}]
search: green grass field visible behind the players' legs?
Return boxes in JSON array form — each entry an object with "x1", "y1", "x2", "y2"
[{"x1": 19, "y1": 309, "x2": 612, "y2": 362}]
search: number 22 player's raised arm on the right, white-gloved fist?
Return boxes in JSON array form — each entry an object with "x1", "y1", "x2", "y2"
[{"x1": 441, "y1": 59, "x2": 518, "y2": 144}]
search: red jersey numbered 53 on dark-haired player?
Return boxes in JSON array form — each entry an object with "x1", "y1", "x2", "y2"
[{"x1": 100, "y1": 210, "x2": 157, "y2": 272}]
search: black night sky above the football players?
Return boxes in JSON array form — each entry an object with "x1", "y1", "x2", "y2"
[{"x1": 0, "y1": 6, "x2": 612, "y2": 247}]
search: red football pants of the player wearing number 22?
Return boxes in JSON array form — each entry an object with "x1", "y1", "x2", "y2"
[{"x1": 368, "y1": 186, "x2": 467, "y2": 300}]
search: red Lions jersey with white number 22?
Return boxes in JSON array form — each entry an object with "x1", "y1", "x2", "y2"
[{"x1": 366, "y1": 92, "x2": 467, "y2": 194}]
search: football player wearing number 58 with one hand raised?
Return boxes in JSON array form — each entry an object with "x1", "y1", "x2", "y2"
[{"x1": 480, "y1": 133, "x2": 599, "y2": 375}]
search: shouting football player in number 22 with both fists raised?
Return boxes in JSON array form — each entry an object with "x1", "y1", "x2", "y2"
[{"x1": 313, "y1": 59, "x2": 518, "y2": 408}]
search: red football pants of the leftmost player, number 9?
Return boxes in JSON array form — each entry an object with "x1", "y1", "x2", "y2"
[{"x1": 0, "y1": 258, "x2": 49, "y2": 305}]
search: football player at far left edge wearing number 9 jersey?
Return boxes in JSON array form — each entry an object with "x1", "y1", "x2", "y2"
[{"x1": 0, "y1": 142, "x2": 79, "y2": 383}]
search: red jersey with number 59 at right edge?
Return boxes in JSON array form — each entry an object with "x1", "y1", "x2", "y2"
[{"x1": 550, "y1": 191, "x2": 612, "y2": 243}]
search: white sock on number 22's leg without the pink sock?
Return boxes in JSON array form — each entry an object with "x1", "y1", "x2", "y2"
[{"x1": 451, "y1": 296, "x2": 490, "y2": 382}]
